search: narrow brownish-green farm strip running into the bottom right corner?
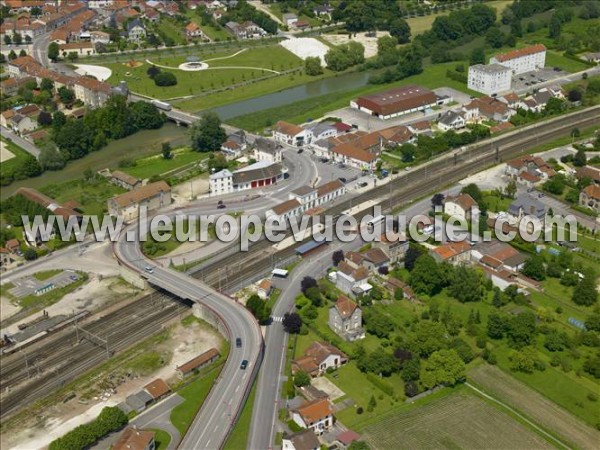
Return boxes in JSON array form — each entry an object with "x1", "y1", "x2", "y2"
[{"x1": 468, "y1": 364, "x2": 600, "y2": 448}]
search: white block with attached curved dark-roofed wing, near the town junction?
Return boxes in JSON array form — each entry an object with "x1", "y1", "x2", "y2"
[{"x1": 208, "y1": 161, "x2": 285, "y2": 195}]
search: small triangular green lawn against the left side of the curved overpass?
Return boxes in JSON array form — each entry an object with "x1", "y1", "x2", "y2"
[{"x1": 170, "y1": 366, "x2": 224, "y2": 436}]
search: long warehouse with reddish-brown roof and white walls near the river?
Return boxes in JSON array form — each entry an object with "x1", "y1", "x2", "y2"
[{"x1": 350, "y1": 85, "x2": 438, "y2": 120}]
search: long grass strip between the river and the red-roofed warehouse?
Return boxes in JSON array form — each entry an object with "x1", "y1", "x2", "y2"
[{"x1": 228, "y1": 62, "x2": 480, "y2": 130}]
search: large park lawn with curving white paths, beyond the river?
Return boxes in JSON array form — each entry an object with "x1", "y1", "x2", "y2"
[{"x1": 103, "y1": 45, "x2": 302, "y2": 99}]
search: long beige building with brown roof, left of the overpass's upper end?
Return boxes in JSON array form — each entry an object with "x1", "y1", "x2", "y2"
[{"x1": 108, "y1": 181, "x2": 171, "y2": 222}]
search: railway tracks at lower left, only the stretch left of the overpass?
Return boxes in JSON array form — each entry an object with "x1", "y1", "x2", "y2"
[{"x1": 0, "y1": 292, "x2": 186, "y2": 419}]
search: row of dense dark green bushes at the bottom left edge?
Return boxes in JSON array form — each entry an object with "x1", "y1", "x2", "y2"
[{"x1": 48, "y1": 406, "x2": 129, "y2": 450}]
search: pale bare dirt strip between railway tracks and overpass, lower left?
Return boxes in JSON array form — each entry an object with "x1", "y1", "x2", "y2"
[{"x1": 1, "y1": 314, "x2": 222, "y2": 450}]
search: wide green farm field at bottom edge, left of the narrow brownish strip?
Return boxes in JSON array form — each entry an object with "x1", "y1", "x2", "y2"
[{"x1": 362, "y1": 391, "x2": 553, "y2": 450}]
